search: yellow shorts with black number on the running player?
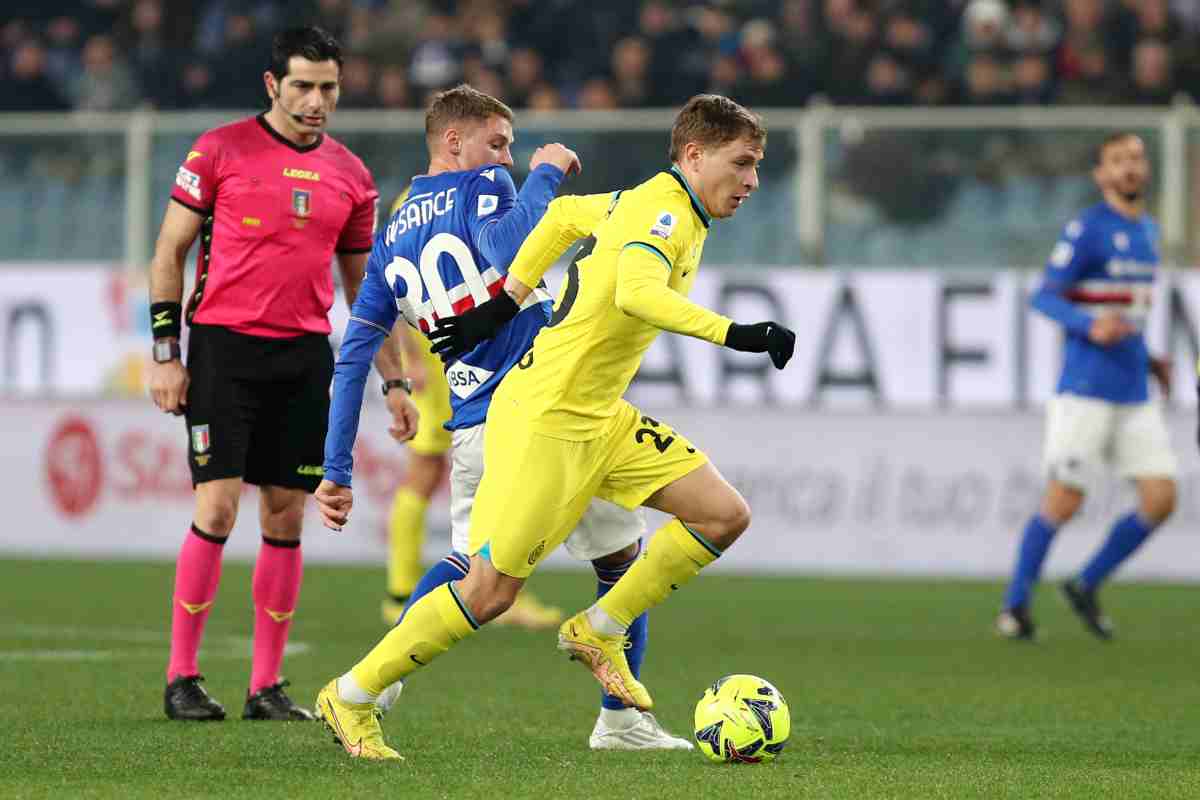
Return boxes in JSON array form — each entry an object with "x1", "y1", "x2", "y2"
[{"x1": 470, "y1": 399, "x2": 708, "y2": 578}]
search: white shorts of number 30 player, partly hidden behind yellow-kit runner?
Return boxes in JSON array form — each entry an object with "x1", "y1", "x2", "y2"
[{"x1": 450, "y1": 425, "x2": 646, "y2": 561}]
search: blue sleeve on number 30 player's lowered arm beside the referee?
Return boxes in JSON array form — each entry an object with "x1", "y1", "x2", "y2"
[{"x1": 324, "y1": 245, "x2": 398, "y2": 486}]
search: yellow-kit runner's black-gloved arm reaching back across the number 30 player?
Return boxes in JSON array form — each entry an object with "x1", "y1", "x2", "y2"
[{"x1": 430, "y1": 190, "x2": 613, "y2": 360}]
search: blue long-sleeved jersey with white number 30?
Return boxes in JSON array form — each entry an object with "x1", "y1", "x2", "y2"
[{"x1": 325, "y1": 164, "x2": 563, "y2": 486}]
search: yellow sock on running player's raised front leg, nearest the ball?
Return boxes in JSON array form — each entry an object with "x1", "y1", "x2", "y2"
[{"x1": 596, "y1": 519, "x2": 721, "y2": 627}]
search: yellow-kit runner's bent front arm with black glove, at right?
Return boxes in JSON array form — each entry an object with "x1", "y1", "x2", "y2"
[{"x1": 616, "y1": 212, "x2": 796, "y2": 369}]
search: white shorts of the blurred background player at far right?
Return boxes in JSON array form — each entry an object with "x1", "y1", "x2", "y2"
[{"x1": 1043, "y1": 395, "x2": 1178, "y2": 491}]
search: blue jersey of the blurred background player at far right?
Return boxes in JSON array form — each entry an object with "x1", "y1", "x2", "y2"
[{"x1": 1032, "y1": 203, "x2": 1158, "y2": 403}]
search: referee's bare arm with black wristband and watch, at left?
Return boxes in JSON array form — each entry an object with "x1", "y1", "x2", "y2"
[{"x1": 149, "y1": 201, "x2": 204, "y2": 415}]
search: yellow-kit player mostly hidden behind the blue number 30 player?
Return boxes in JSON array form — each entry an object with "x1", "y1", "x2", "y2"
[{"x1": 380, "y1": 188, "x2": 563, "y2": 630}]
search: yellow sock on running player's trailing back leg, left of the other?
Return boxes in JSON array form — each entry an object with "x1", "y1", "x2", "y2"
[{"x1": 350, "y1": 583, "x2": 479, "y2": 696}]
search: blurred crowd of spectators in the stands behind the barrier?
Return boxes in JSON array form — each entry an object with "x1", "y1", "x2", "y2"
[{"x1": 0, "y1": 0, "x2": 1200, "y2": 110}]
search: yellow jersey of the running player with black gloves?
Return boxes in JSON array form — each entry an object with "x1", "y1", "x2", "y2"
[{"x1": 497, "y1": 163, "x2": 731, "y2": 441}]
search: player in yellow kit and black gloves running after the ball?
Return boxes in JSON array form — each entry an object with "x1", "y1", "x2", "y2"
[{"x1": 322, "y1": 95, "x2": 796, "y2": 754}]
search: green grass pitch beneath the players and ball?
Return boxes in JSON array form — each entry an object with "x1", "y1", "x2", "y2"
[{"x1": 0, "y1": 560, "x2": 1200, "y2": 800}]
